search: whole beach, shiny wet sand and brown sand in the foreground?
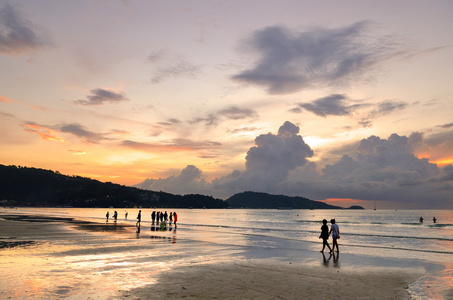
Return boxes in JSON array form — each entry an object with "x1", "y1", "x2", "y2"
[{"x1": 0, "y1": 210, "x2": 452, "y2": 299}]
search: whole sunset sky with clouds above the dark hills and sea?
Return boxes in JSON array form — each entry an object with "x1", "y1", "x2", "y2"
[{"x1": 0, "y1": 0, "x2": 453, "y2": 209}]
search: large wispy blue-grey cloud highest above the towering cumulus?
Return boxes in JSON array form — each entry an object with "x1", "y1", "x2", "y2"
[{"x1": 232, "y1": 21, "x2": 397, "y2": 94}]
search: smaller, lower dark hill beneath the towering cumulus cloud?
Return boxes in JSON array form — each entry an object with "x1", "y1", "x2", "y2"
[{"x1": 226, "y1": 192, "x2": 341, "y2": 209}]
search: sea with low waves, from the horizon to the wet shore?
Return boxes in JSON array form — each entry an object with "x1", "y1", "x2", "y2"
[{"x1": 0, "y1": 208, "x2": 453, "y2": 299}]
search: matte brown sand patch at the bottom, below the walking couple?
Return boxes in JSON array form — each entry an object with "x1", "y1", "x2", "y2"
[{"x1": 121, "y1": 261, "x2": 419, "y2": 300}]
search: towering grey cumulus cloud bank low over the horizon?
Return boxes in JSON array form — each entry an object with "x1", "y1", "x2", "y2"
[{"x1": 135, "y1": 122, "x2": 453, "y2": 208}]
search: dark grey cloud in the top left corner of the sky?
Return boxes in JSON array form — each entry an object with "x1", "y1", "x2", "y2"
[{"x1": 0, "y1": 3, "x2": 50, "y2": 55}]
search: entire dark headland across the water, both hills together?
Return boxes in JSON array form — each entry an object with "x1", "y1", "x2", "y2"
[{"x1": 0, "y1": 165, "x2": 361, "y2": 209}]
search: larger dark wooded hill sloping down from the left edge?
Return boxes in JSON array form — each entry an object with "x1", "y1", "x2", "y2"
[{"x1": 0, "y1": 165, "x2": 228, "y2": 208}]
